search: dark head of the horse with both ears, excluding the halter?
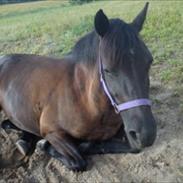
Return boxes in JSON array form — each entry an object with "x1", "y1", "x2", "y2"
[{"x1": 95, "y1": 3, "x2": 156, "y2": 150}]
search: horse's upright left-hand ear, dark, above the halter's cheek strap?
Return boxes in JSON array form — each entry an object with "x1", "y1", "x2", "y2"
[{"x1": 95, "y1": 9, "x2": 109, "y2": 37}]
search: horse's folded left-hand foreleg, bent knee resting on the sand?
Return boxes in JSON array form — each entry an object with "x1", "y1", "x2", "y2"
[{"x1": 42, "y1": 131, "x2": 87, "y2": 171}]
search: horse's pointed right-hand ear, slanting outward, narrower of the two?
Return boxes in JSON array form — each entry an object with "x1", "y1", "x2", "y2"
[{"x1": 132, "y1": 2, "x2": 149, "y2": 32}]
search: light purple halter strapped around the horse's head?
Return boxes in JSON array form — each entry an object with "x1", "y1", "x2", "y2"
[{"x1": 99, "y1": 51, "x2": 151, "y2": 113}]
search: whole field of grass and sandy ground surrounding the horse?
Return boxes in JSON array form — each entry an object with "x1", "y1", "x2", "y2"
[{"x1": 0, "y1": 0, "x2": 183, "y2": 183}]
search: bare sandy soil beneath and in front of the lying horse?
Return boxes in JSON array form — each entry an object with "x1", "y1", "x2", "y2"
[{"x1": 0, "y1": 67, "x2": 183, "y2": 183}]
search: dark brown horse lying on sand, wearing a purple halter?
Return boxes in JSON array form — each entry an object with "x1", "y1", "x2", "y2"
[{"x1": 0, "y1": 3, "x2": 156, "y2": 170}]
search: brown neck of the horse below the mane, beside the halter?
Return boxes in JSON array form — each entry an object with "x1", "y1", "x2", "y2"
[{"x1": 74, "y1": 60, "x2": 109, "y2": 115}]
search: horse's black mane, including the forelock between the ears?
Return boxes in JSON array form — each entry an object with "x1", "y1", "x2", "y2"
[{"x1": 69, "y1": 19, "x2": 138, "y2": 65}]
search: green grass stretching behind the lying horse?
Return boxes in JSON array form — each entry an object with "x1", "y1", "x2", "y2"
[{"x1": 0, "y1": 0, "x2": 183, "y2": 87}]
